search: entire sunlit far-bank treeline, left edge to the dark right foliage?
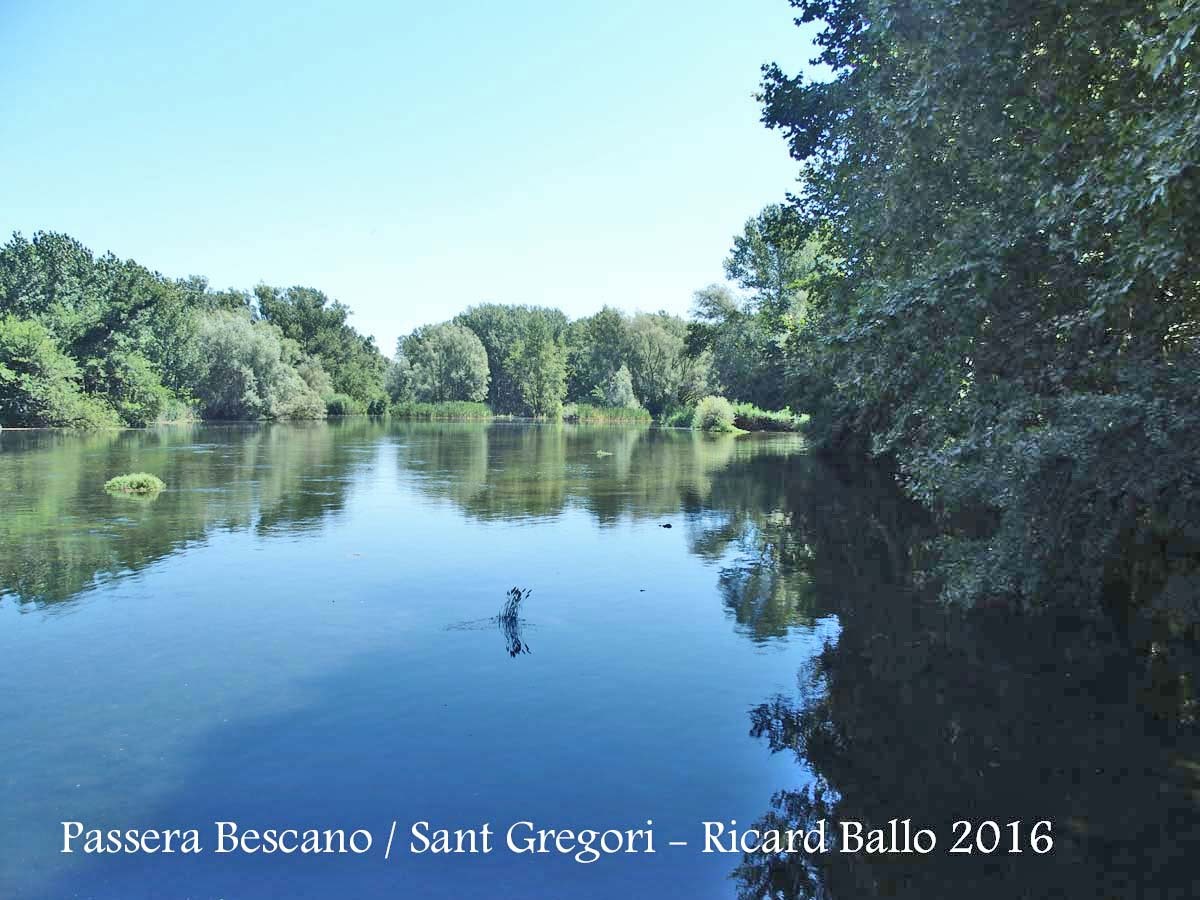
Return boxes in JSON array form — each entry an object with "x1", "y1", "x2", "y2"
[{"x1": 0, "y1": 230, "x2": 810, "y2": 430}]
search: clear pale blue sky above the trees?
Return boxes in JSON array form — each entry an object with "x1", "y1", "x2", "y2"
[{"x1": 0, "y1": 0, "x2": 814, "y2": 354}]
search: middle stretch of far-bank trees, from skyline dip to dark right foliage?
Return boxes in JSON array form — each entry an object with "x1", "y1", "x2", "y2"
[{"x1": 388, "y1": 205, "x2": 821, "y2": 431}]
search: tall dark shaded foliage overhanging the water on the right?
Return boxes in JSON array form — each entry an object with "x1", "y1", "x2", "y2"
[{"x1": 749, "y1": 0, "x2": 1200, "y2": 613}]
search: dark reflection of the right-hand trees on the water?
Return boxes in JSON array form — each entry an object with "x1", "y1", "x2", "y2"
[{"x1": 709, "y1": 457, "x2": 1200, "y2": 898}]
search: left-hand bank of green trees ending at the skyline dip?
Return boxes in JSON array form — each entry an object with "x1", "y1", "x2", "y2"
[{"x1": 0, "y1": 233, "x2": 388, "y2": 427}]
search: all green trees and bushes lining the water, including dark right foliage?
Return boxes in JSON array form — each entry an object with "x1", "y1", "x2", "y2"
[{"x1": 0, "y1": 0, "x2": 1200, "y2": 640}]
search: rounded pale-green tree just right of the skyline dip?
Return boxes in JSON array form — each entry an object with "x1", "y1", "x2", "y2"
[{"x1": 397, "y1": 322, "x2": 488, "y2": 403}]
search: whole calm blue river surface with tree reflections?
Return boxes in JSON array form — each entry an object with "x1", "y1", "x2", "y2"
[{"x1": 0, "y1": 420, "x2": 1200, "y2": 898}]
